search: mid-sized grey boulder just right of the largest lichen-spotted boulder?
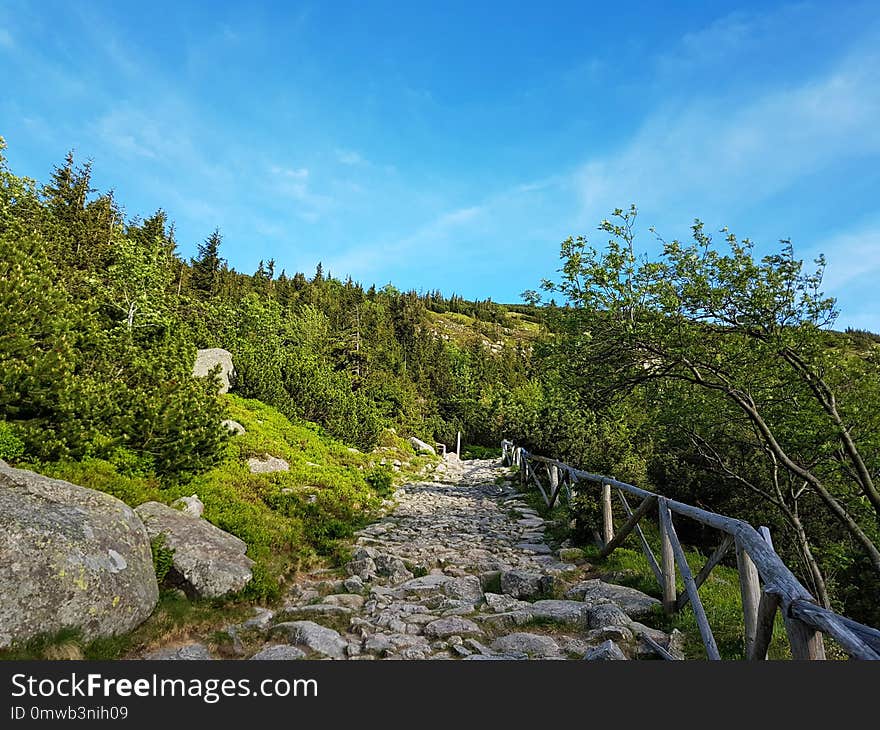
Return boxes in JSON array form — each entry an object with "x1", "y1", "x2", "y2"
[{"x1": 135, "y1": 502, "x2": 254, "y2": 598}]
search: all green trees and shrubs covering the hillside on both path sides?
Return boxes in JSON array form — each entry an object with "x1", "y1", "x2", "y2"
[{"x1": 0, "y1": 139, "x2": 880, "y2": 652}]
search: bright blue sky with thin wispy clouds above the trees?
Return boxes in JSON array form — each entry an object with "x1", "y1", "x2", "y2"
[{"x1": 0, "y1": 0, "x2": 880, "y2": 331}]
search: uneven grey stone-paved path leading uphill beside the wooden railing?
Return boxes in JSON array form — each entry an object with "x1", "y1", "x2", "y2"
[{"x1": 150, "y1": 457, "x2": 680, "y2": 660}]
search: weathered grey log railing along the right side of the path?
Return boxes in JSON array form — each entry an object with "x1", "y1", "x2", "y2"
[{"x1": 501, "y1": 440, "x2": 880, "y2": 660}]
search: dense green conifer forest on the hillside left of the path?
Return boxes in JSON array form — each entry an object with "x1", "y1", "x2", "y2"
[{"x1": 0, "y1": 141, "x2": 529, "y2": 480}]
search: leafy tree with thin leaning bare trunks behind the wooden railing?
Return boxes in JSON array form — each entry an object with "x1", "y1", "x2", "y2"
[{"x1": 545, "y1": 207, "x2": 880, "y2": 572}]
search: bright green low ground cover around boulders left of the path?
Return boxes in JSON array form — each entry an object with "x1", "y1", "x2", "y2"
[{"x1": 0, "y1": 395, "x2": 429, "y2": 659}]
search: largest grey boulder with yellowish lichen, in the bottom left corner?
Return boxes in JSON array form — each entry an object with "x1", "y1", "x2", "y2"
[{"x1": 0, "y1": 461, "x2": 159, "y2": 646}]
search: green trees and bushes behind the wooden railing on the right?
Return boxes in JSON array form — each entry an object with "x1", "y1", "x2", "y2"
[{"x1": 519, "y1": 208, "x2": 880, "y2": 623}]
